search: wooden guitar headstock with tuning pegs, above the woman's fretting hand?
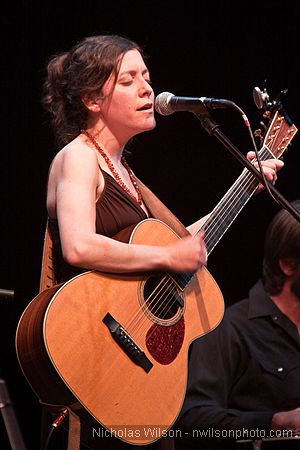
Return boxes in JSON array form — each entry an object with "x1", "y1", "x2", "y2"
[{"x1": 263, "y1": 110, "x2": 298, "y2": 158}]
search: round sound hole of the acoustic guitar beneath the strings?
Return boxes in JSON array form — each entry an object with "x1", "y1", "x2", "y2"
[{"x1": 144, "y1": 275, "x2": 184, "y2": 320}]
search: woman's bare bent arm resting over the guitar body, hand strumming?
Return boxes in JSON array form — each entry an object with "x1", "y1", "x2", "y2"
[{"x1": 48, "y1": 145, "x2": 203, "y2": 273}]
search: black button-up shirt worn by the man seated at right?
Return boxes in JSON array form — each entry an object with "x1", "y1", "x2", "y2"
[{"x1": 174, "y1": 281, "x2": 300, "y2": 448}]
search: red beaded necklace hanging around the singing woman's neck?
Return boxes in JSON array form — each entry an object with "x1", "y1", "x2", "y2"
[{"x1": 81, "y1": 130, "x2": 143, "y2": 205}]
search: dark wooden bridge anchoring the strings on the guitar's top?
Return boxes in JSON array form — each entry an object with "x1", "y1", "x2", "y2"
[{"x1": 102, "y1": 313, "x2": 153, "y2": 373}]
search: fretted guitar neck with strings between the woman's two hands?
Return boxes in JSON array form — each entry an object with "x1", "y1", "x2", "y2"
[{"x1": 198, "y1": 147, "x2": 273, "y2": 255}]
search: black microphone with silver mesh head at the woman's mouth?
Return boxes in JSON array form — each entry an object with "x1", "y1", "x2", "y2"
[{"x1": 154, "y1": 92, "x2": 236, "y2": 116}]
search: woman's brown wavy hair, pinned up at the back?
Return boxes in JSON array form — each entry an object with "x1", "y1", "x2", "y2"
[{"x1": 42, "y1": 35, "x2": 144, "y2": 146}]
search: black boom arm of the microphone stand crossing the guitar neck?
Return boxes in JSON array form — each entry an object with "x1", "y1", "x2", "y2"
[{"x1": 194, "y1": 104, "x2": 300, "y2": 223}]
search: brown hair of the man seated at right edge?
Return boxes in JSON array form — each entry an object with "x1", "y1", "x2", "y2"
[{"x1": 263, "y1": 199, "x2": 300, "y2": 295}]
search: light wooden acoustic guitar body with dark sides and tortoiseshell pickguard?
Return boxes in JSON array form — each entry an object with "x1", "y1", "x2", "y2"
[{"x1": 16, "y1": 219, "x2": 224, "y2": 444}]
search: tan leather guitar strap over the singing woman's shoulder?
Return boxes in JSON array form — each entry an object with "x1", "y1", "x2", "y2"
[{"x1": 39, "y1": 179, "x2": 189, "y2": 450}]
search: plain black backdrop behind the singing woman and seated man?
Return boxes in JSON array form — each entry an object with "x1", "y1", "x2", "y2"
[{"x1": 0, "y1": 0, "x2": 300, "y2": 450}]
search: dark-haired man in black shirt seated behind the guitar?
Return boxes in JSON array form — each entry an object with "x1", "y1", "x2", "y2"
[{"x1": 175, "y1": 199, "x2": 300, "y2": 450}]
